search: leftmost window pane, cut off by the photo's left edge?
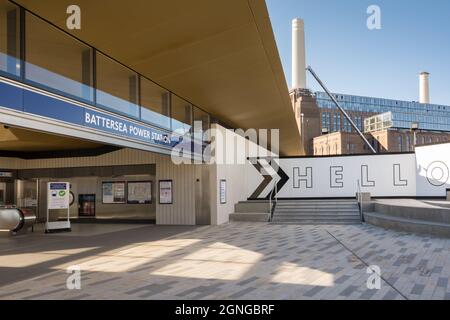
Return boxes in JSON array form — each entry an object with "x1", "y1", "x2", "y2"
[{"x1": 0, "y1": 0, "x2": 20, "y2": 77}]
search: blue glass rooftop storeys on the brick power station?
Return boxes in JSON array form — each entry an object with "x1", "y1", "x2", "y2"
[{"x1": 315, "y1": 92, "x2": 450, "y2": 132}]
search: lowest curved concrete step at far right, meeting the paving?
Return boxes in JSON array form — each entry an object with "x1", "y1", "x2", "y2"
[{"x1": 364, "y1": 212, "x2": 450, "y2": 238}]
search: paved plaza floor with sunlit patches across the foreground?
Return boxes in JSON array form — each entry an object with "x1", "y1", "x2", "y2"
[{"x1": 0, "y1": 223, "x2": 450, "y2": 300}]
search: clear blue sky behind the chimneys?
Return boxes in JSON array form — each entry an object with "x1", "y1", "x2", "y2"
[{"x1": 266, "y1": 0, "x2": 450, "y2": 105}]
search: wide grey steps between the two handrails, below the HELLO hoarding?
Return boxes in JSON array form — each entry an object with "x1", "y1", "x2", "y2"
[{"x1": 272, "y1": 200, "x2": 361, "y2": 225}]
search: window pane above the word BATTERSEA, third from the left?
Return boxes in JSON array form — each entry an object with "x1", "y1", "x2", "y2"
[{"x1": 96, "y1": 52, "x2": 139, "y2": 118}]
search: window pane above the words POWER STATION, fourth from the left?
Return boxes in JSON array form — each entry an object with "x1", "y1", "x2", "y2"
[{"x1": 141, "y1": 77, "x2": 170, "y2": 130}]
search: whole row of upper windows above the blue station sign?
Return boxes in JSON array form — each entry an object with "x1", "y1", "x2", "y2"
[{"x1": 0, "y1": 0, "x2": 211, "y2": 148}]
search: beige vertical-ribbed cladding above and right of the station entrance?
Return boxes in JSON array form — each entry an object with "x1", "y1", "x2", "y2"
[{"x1": 0, "y1": 149, "x2": 195, "y2": 225}]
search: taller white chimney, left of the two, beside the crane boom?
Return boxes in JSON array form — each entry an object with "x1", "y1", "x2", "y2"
[{"x1": 292, "y1": 18, "x2": 306, "y2": 89}]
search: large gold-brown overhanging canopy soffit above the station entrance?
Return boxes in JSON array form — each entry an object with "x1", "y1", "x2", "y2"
[{"x1": 16, "y1": 0, "x2": 302, "y2": 155}]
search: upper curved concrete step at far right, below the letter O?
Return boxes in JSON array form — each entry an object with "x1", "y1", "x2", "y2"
[{"x1": 373, "y1": 203, "x2": 450, "y2": 224}]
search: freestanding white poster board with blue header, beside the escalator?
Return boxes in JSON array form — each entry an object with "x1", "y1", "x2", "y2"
[{"x1": 45, "y1": 182, "x2": 71, "y2": 233}]
